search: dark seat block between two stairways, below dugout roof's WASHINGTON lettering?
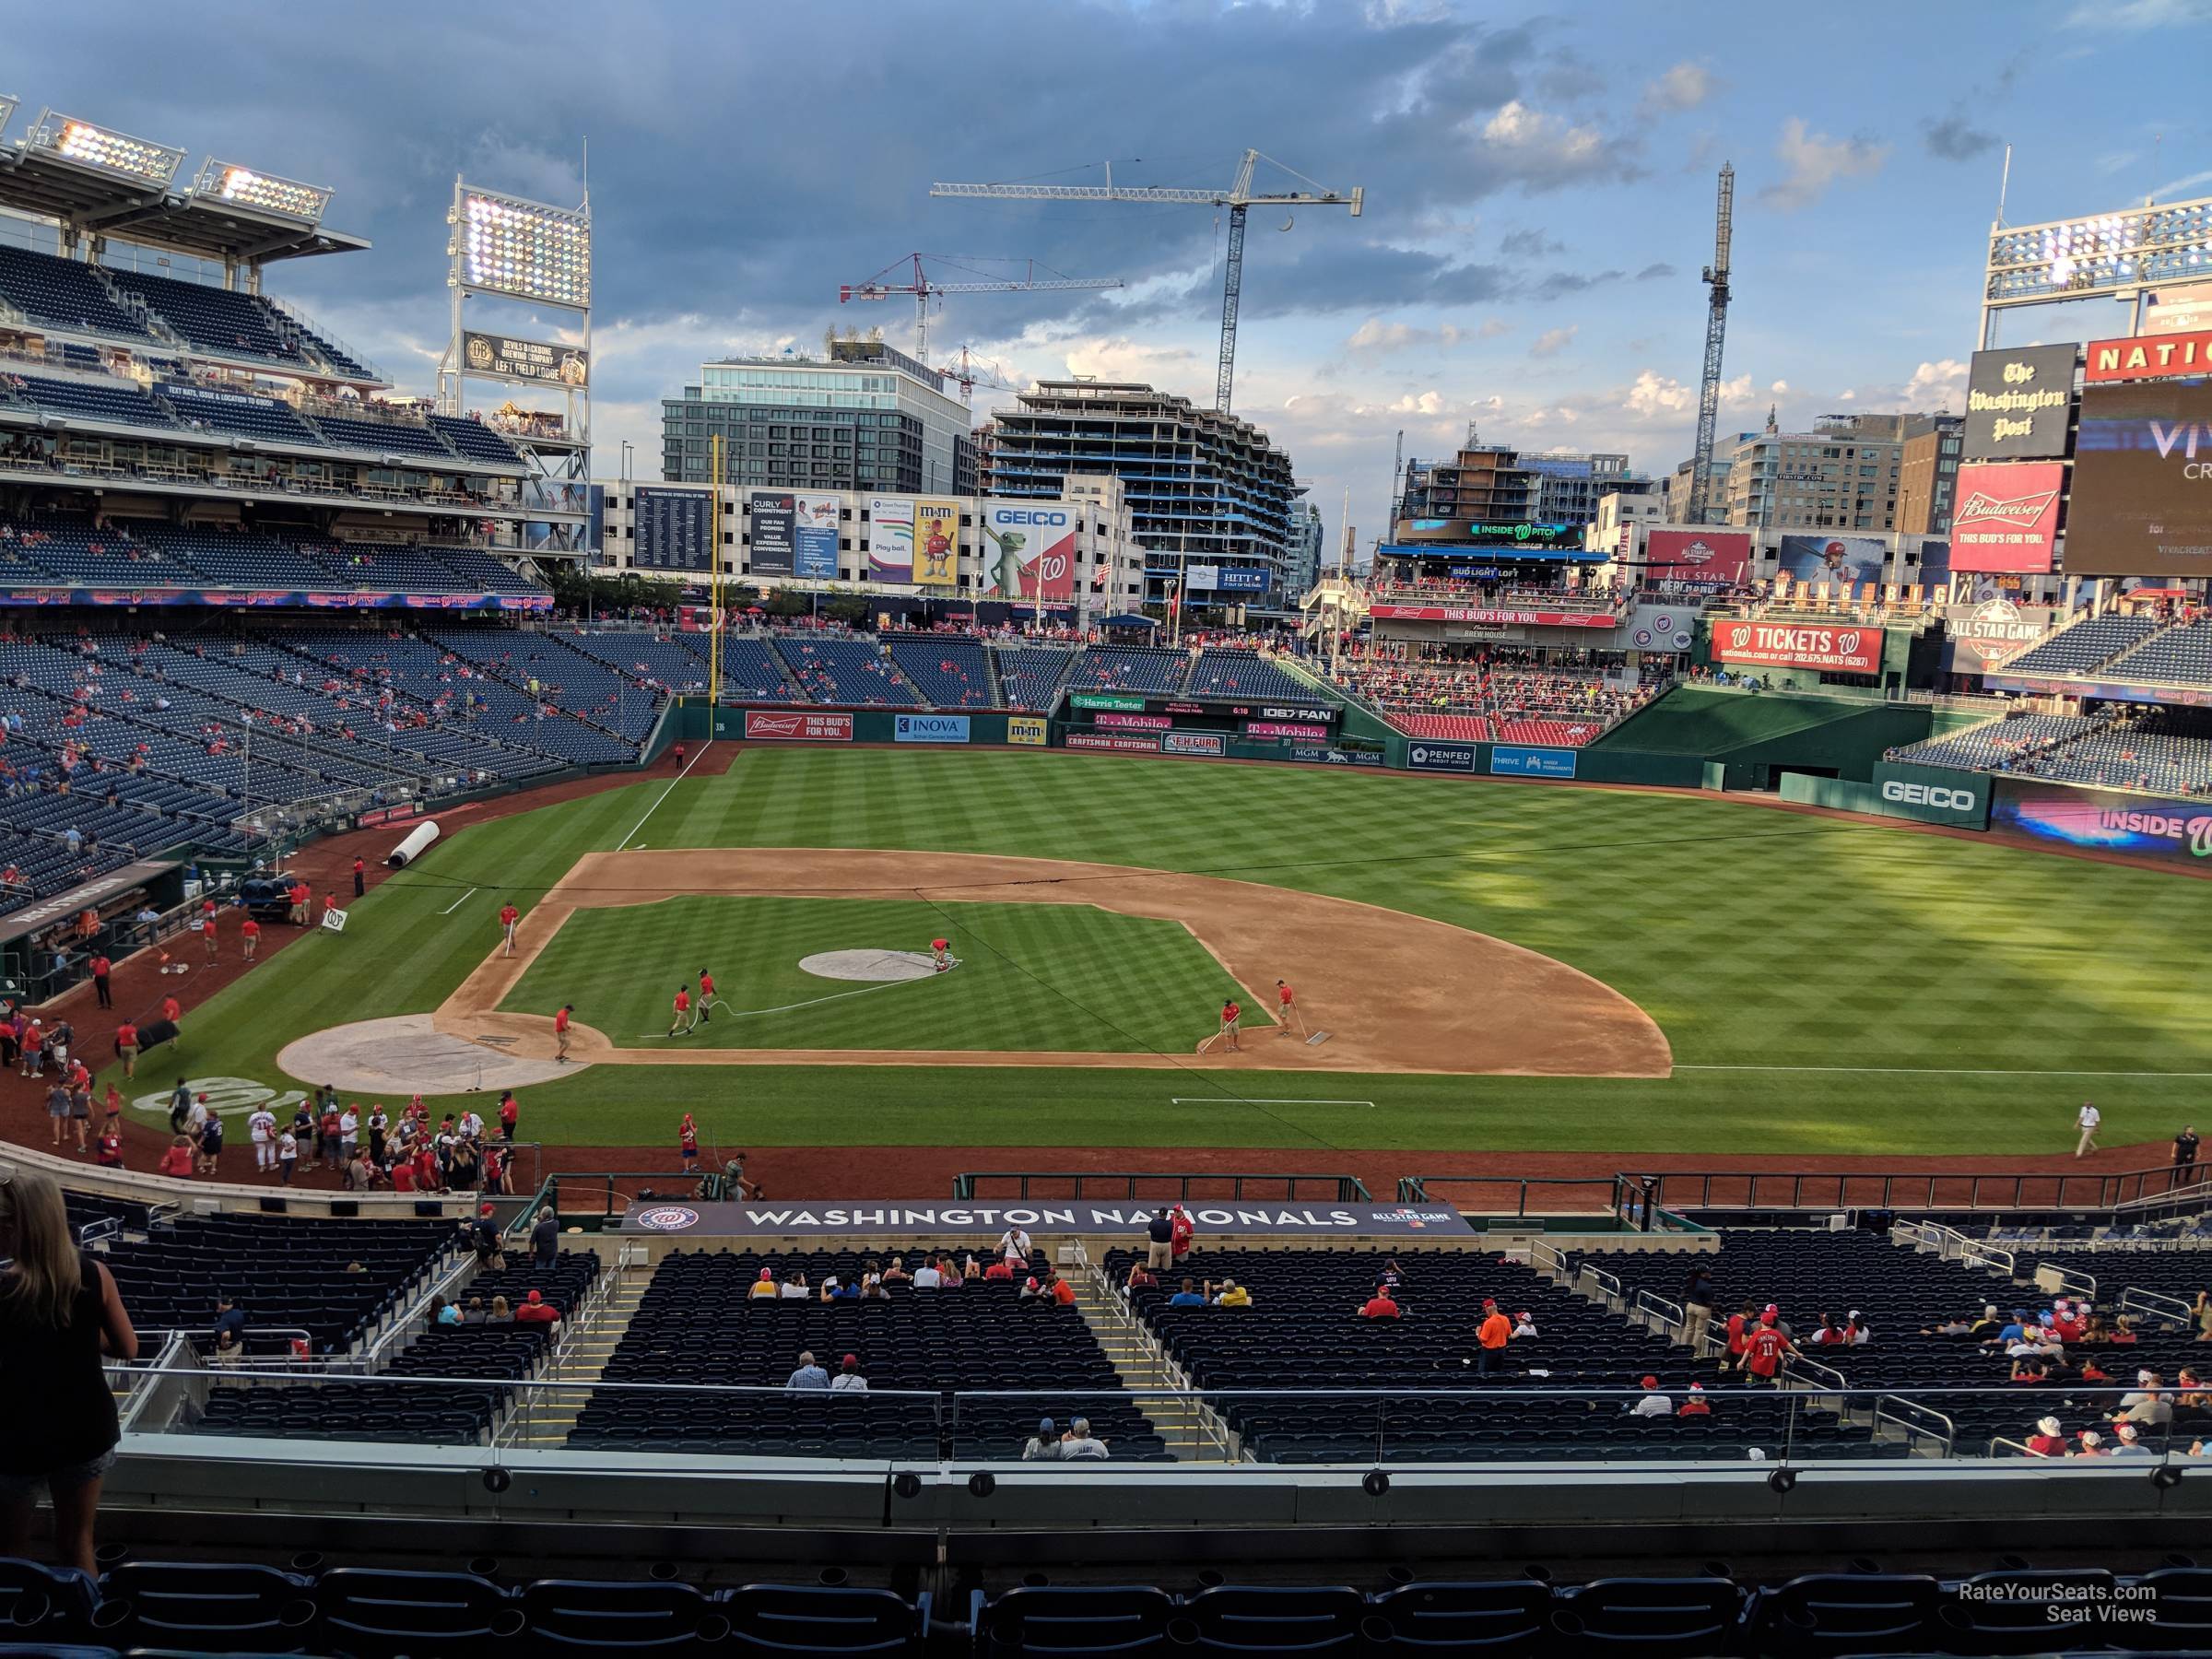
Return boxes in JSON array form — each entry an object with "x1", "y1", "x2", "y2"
[{"x1": 569, "y1": 1250, "x2": 1171, "y2": 1462}]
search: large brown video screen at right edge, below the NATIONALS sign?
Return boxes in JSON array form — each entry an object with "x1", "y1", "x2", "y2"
[{"x1": 2066, "y1": 381, "x2": 2212, "y2": 575}]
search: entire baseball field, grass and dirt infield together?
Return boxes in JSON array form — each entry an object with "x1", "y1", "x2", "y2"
[{"x1": 126, "y1": 746, "x2": 2212, "y2": 1168}]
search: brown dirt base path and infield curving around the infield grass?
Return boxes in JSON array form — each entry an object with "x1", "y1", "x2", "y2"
[{"x1": 406, "y1": 847, "x2": 1672, "y2": 1090}]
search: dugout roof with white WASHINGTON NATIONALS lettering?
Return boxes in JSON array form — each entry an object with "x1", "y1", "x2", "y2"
[{"x1": 621, "y1": 1199, "x2": 1473, "y2": 1239}]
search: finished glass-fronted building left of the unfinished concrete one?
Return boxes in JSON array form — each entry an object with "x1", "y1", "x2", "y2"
[{"x1": 662, "y1": 341, "x2": 975, "y2": 496}]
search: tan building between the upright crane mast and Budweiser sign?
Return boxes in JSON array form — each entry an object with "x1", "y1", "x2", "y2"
[{"x1": 1712, "y1": 414, "x2": 1934, "y2": 531}]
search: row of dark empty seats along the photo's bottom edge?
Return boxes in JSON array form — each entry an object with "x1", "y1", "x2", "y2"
[{"x1": 0, "y1": 1550, "x2": 2212, "y2": 1659}]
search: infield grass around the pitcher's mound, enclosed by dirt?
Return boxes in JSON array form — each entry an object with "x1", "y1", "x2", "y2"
[{"x1": 500, "y1": 896, "x2": 1272, "y2": 1053}]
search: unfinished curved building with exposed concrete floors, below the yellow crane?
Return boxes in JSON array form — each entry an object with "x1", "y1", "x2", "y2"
[{"x1": 978, "y1": 381, "x2": 1299, "y2": 610}]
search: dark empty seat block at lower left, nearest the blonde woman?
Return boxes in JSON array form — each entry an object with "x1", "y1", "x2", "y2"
[{"x1": 101, "y1": 1215, "x2": 458, "y2": 1354}]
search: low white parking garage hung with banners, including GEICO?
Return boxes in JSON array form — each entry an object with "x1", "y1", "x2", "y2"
[{"x1": 597, "y1": 476, "x2": 1146, "y2": 615}]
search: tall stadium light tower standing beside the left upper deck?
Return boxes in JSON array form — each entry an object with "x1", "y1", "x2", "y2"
[{"x1": 438, "y1": 177, "x2": 591, "y2": 555}]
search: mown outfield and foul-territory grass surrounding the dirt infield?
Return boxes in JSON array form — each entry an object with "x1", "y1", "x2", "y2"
[{"x1": 125, "y1": 747, "x2": 2212, "y2": 1155}]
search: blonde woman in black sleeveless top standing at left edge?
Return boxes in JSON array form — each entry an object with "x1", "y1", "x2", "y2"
[{"x1": 0, "y1": 1171, "x2": 137, "y2": 1572}]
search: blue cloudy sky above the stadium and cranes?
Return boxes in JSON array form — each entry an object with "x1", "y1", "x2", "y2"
[{"x1": 0, "y1": 0, "x2": 2212, "y2": 559}]
